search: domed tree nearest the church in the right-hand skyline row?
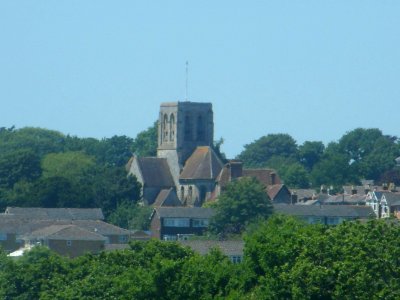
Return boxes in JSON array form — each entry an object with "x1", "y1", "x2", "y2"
[{"x1": 238, "y1": 133, "x2": 298, "y2": 167}]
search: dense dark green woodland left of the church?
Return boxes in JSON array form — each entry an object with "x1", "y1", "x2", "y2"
[{"x1": 0, "y1": 124, "x2": 157, "y2": 228}]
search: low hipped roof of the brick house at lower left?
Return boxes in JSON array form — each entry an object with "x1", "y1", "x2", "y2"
[{"x1": 25, "y1": 225, "x2": 106, "y2": 241}]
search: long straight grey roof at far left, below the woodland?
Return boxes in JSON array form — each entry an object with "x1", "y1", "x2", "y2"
[{"x1": 5, "y1": 207, "x2": 104, "y2": 220}]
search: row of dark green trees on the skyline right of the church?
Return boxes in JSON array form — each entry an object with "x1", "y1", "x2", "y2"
[{"x1": 237, "y1": 128, "x2": 400, "y2": 188}]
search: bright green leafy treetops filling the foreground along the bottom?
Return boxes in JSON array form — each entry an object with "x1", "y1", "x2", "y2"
[{"x1": 0, "y1": 215, "x2": 400, "y2": 300}]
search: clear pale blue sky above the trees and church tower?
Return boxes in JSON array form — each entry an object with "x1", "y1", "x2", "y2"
[{"x1": 0, "y1": 0, "x2": 400, "y2": 157}]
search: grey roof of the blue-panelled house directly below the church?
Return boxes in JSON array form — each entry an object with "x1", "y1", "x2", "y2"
[{"x1": 153, "y1": 207, "x2": 214, "y2": 219}]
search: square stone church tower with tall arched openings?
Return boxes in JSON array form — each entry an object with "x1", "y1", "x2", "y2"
[{"x1": 157, "y1": 101, "x2": 214, "y2": 186}]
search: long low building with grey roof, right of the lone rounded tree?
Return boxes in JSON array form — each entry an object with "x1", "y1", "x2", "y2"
[{"x1": 274, "y1": 204, "x2": 375, "y2": 225}]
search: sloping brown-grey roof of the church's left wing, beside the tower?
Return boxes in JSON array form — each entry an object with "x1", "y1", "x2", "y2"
[{"x1": 135, "y1": 157, "x2": 175, "y2": 188}]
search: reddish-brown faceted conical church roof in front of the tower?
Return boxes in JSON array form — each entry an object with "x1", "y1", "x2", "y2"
[{"x1": 180, "y1": 146, "x2": 223, "y2": 179}]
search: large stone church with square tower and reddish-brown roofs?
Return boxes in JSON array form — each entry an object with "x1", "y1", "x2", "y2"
[{"x1": 127, "y1": 101, "x2": 281, "y2": 207}]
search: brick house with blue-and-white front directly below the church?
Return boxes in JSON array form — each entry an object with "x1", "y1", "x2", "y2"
[{"x1": 150, "y1": 207, "x2": 214, "y2": 240}]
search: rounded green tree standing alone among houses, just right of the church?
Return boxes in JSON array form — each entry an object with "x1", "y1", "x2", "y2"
[{"x1": 211, "y1": 177, "x2": 272, "y2": 234}]
